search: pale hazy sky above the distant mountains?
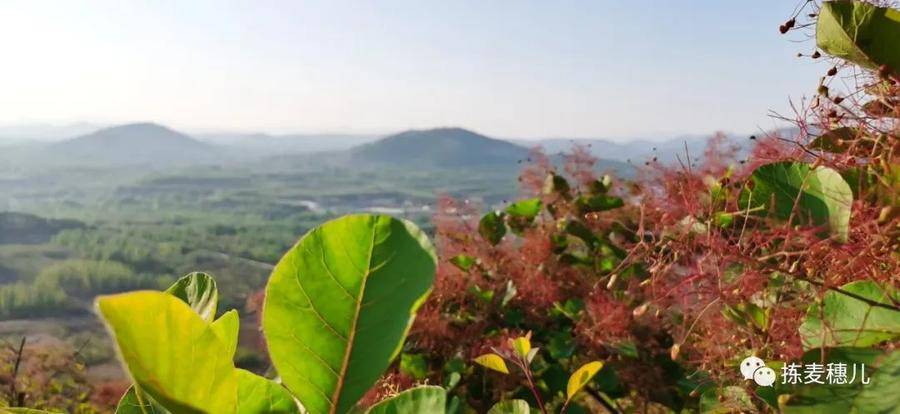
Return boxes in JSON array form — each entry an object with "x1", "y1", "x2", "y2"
[{"x1": 0, "y1": 0, "x2": 823, "y2": 141}]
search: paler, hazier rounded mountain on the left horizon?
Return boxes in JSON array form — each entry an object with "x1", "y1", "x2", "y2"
[{"x1": 48, "y1": 123, "x2": 217, "y2": 165}]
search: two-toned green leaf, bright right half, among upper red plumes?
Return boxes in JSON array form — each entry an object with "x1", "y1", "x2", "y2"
[{"x1": 741, "y1": 162, "x2": 853, "y2": 241}]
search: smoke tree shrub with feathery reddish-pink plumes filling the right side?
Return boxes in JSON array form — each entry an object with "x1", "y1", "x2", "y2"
[{"x1": 391, "y1": 2, "x2": 900, "y2": 412}]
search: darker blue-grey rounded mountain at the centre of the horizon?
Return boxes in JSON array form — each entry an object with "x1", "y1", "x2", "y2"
[{"x1": 348, "y1": 128, "x2": 528, "y2": 168}]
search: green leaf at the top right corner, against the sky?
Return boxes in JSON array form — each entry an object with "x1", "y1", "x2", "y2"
[{"x1": 816, "y1": 1, "x2": 900, "y2": 73}]
